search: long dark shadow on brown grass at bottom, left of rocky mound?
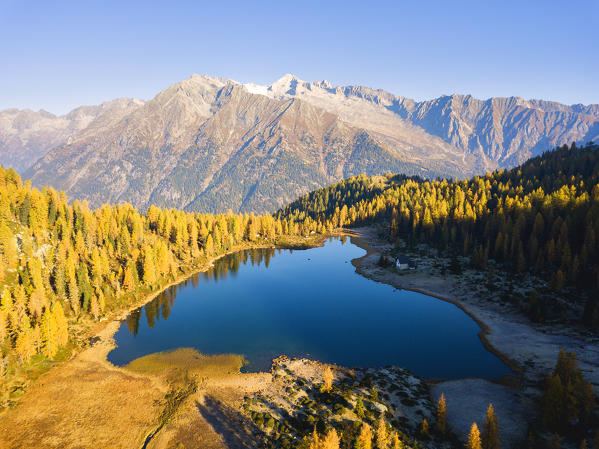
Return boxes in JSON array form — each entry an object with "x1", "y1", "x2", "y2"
[{"x1": 196, "y1": 396, "x2": 263, "y2": 449}]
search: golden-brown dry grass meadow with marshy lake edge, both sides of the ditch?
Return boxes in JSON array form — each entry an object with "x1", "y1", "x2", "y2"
[{"x1": 0, "y1": 322, "x2": 270, "y2": 449}]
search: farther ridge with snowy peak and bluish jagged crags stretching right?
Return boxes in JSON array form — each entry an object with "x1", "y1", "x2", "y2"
[{"x1": 251, "y1": 75, "x2": 599, "y2": 169}]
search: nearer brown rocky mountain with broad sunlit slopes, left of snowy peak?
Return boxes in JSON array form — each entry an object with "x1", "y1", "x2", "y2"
[{"x1": 26, "y1": 76, "x2": 474, "y2": 212}]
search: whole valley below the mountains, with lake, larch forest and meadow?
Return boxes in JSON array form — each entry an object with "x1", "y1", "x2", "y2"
[{"x1": 0, "y1": 145, "x2": 599, "y2": 449}]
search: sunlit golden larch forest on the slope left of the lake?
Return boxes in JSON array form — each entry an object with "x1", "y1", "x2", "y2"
[{"x1": 0, "y1": 167, "x2": 315, "y2": 386}]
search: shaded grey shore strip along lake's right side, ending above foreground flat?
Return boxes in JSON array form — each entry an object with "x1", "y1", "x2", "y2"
[{"x1": 351, "y1": 227, "x2": 599, "y2": 391}]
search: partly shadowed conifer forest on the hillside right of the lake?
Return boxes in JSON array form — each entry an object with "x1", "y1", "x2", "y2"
[{"x1": 275, "y1": 143, "x2": 599, "y2": 329}]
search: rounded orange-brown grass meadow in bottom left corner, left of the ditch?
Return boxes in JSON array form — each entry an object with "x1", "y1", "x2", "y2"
[{"x1": 0, "y1": 350, "x2": 164, "y2": 449}]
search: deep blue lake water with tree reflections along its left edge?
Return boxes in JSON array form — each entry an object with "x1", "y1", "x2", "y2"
[{"x1": 108, "y1": 238, "x2": 510, "y2": 379}]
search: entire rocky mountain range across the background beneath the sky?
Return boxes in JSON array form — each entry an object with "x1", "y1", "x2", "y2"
[{"x1": 0, "y1": 75, "x2": 599, "y2": 212}]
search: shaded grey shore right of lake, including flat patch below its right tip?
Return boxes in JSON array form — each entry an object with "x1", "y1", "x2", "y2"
[{"x1": 352, "y1": 228, "x2": 599, "y2": 448}]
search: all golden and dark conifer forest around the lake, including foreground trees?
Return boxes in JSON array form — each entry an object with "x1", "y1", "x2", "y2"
[{"x1": 0, "y1": 144, "x2": 599, "y2": 449}]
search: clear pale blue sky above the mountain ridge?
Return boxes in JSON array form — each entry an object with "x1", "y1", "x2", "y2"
[{"x1": 0, "y1": 0, "x2": 599, "y2": 113}]
